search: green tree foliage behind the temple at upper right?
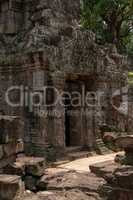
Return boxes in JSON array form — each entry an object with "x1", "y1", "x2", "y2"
[{"x1": 81, "y1": 0, "x2": 133, "y2": 52}]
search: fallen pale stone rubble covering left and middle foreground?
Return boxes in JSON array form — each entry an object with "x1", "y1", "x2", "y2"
[{"x1": 0, "y1": 157, "x2": 106, "y2": 200}]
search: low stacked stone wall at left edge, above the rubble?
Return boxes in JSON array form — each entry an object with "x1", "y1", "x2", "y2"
[{"x1": 0, "y1": 115, "x2": 24, "y2": 172}]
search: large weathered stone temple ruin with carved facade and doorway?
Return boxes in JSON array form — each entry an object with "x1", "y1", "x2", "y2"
[{"x1": 0, "y1": 0, "x2": 129, "y2": 199}]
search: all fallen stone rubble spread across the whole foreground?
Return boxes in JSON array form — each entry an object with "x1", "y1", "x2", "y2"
[{"x1": 0, "y1": 153, "x2": 133, "y2": 200}]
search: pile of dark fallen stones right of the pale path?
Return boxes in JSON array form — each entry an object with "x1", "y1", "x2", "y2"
[{"x1": 90, "y1": 159, "x2": 133, "y2": 200}]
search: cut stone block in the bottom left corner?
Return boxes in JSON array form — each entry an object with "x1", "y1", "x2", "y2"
[{"x1": 0, "y1": 174, "x2": 24, "y2": 200}]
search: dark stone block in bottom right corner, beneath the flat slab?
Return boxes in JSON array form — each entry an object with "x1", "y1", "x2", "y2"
[{"x1": 100, "y1": 165, "x2": 133, "y2": 200}]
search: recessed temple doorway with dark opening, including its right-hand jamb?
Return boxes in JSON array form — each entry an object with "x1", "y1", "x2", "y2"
[{"x1": 65, "y1": 76, "x2": 96, "y2": 147}]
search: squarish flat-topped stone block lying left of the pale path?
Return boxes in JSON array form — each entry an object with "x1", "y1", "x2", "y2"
[{"x1": 16, "y1": 157, "x2": 46, "y2": 177}]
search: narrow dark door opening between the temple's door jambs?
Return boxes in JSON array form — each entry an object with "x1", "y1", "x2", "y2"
[{"x1": 65, "y1": 81, "x2": 82, "y2": 147}]
